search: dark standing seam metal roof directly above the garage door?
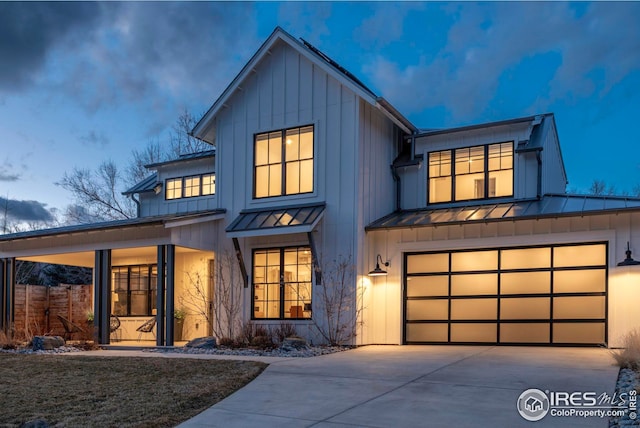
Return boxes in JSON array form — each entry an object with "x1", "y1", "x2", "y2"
[{"x1": 365, "y1": 194, "x2": 640, "y2": 231}]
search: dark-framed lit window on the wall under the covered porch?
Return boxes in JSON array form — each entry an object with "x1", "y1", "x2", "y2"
[{"x1": 111, "y1": 265, "x2": 158, "y2": 316}]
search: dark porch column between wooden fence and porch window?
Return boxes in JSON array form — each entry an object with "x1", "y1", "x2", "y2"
[{"x1": 93, "y1": 250, "x2": 111, "y2": 345}]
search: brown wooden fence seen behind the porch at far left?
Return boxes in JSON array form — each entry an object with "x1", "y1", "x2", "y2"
[{"x1": 14, "y1": 284, "x2": 93, "y2": 336}]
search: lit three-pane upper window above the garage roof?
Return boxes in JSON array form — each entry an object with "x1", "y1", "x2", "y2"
[{"x1": 428, "y1": 141, "x2": 513, "y2": 203}]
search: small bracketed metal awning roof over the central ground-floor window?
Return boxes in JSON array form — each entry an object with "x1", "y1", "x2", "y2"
[{"x1": 226, "y1": 203, "x2": 326, "y2": 233}]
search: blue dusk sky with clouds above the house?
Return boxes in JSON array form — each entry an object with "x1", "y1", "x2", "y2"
[{"x1": 0, "y1": 2, "x2": 640, "y2": 221}]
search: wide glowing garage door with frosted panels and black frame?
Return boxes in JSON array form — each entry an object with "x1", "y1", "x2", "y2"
[{"x1": 404, "y1": 243, "x2": 607, "y2": 345}]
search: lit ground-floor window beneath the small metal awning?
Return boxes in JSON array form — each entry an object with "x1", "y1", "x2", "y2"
[{"x1": 252, "y1": 247, "x2": 311, "y2": 319}]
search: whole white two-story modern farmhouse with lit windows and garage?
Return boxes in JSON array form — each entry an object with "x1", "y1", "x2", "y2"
[{"x1": 0, "y1": 28, "x2": 640, "y2": 346}]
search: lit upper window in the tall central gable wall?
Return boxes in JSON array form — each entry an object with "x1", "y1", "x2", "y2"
[{"x1": 254, "y1": 125, "x2": 313, "y2": 198}]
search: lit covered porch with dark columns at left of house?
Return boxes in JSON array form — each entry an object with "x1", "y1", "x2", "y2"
[{"x1": 0, "y1": 211, "x2": 222, "y2": 346}]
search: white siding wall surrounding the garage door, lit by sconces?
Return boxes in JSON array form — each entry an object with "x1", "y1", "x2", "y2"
[{"x1": 359, "y1": 213, "x2": 640, "y2": 347}]
